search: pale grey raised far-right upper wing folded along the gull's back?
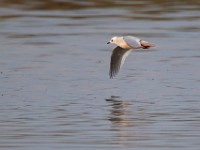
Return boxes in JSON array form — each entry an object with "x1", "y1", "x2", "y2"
[{"x1": 123, "y1": 36, "x2": 141, "y2": 48}]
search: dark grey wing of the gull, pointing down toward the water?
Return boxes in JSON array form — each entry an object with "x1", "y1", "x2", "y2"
[{"x1": 109, "y1": 46, "x2": 131, "y2": 78}]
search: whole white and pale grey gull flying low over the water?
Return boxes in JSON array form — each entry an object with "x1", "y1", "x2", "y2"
[{"x1": 107, "y1": 36, "x2": 155, "y2": 78}]
